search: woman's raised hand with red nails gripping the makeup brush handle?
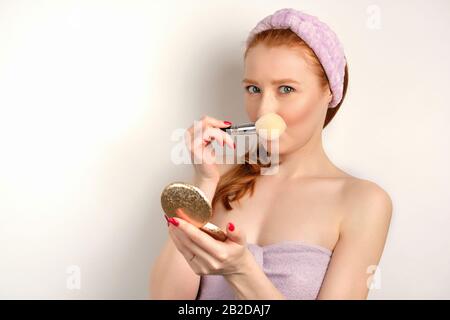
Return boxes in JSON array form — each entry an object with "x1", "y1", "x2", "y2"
[{"x1": 185, "y1": 115, "x2": 234, "y2": 182}]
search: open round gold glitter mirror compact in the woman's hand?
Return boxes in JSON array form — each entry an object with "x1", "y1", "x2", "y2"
[{"x1": 161, "y1": 182, "x2": 227, "y2": 241}]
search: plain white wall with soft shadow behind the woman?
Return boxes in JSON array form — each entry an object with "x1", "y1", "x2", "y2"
[{"x1": 0, "y1": 0, "x2": 450, "y2": 299}]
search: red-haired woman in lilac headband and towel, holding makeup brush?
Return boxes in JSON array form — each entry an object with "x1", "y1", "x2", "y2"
[{"x1": 150, "y1": 9, "x2": 392, "y2": 299}]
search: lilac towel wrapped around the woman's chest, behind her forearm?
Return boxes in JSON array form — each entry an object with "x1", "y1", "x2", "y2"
[{"x1": 197, "y1": 241, "x2": 332, "y2": 300}]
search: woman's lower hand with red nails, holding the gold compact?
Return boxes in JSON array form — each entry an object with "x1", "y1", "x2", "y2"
[{"x1": 166, "y1": 216, "x2": 251, "y2": 275}]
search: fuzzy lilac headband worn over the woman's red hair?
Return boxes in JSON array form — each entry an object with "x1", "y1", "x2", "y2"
[{"x1": 247, "y1": 8, "x2": 346, "y2": 108}]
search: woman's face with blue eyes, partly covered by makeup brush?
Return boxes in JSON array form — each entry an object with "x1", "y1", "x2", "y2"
[{"x1": 243, "y1": 44, "x2": 332, "y2": 154}]
